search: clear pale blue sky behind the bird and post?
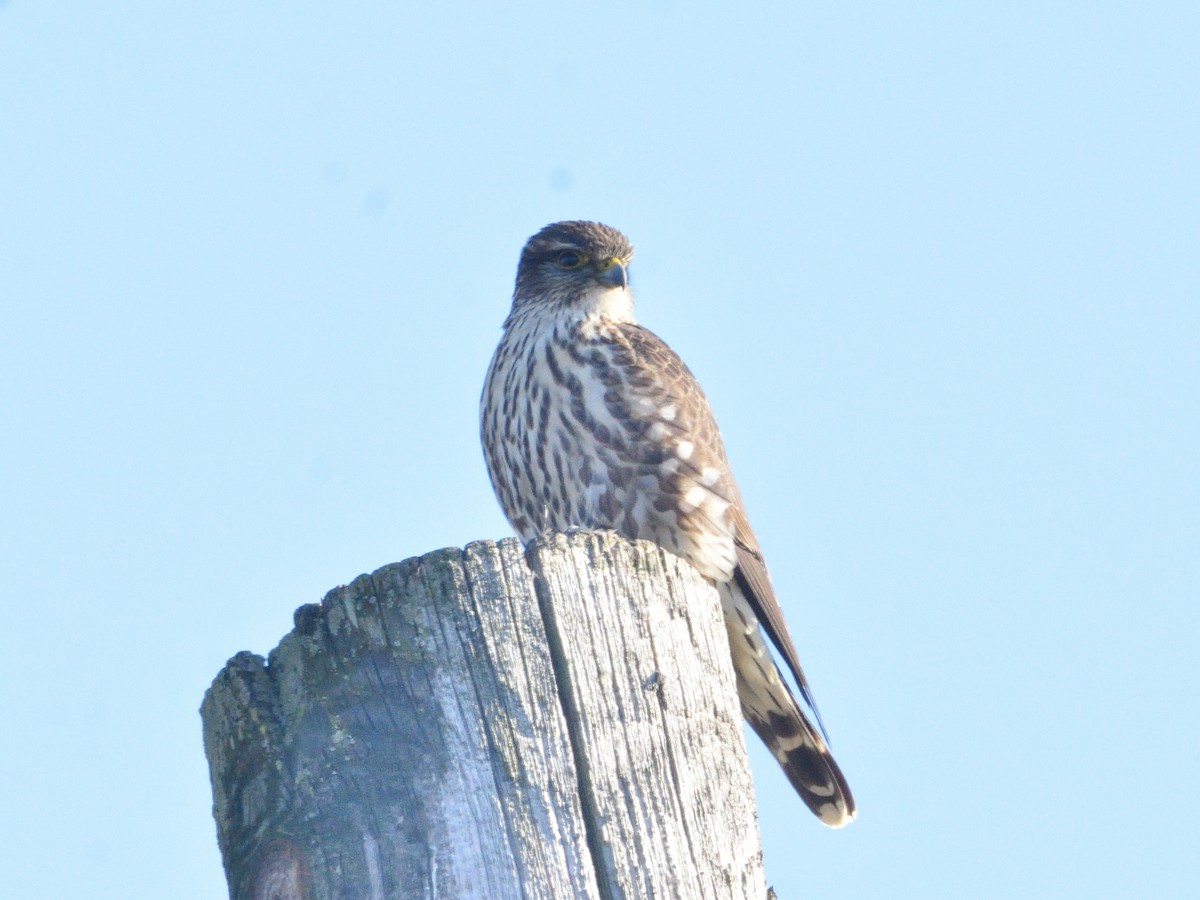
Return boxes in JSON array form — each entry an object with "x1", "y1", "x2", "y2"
[{"x1": 0, "y1": 0, "x2": 1200, "y2": 900}]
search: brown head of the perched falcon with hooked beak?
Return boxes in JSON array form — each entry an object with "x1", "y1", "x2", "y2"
[{"x1": 512, "y1": 222, "x2": 634, "y2": 322}]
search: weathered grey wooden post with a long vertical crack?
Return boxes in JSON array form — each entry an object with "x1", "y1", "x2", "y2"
[{"x1": 200, "y1": 533, "x2": 767, "y2": 900}]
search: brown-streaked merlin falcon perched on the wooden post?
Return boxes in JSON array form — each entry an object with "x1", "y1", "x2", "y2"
[{"x1": 480, "y1": 222, "x2": 854, "y2": 828}]
